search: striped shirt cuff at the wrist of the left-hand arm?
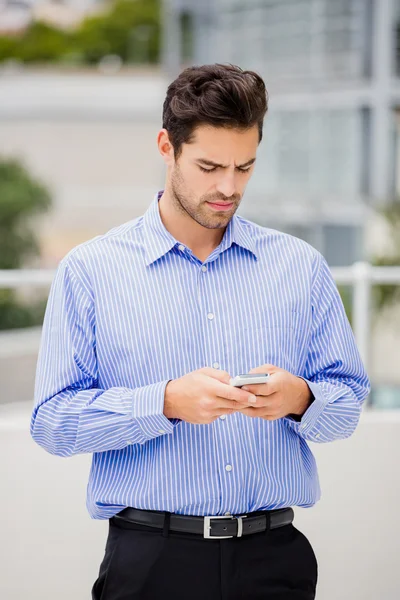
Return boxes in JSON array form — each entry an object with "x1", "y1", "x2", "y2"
[{"x1": 131, "y1": 379, "x2": 181, "y2": 440}]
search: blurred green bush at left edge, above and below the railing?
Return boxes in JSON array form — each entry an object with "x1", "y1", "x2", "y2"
[{"x1": 0, "y1": 159, "x2": 51, "y2": 329}]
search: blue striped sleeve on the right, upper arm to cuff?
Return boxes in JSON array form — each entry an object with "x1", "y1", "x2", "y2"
[{"x1": 285, "y1": 253, "x2": 370, "y2": 442}]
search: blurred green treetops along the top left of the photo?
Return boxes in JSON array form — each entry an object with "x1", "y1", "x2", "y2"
[{"x1": 0, "y1": 0, "x2": 161, "y2": 64}]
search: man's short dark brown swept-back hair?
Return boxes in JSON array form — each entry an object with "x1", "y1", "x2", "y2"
[{"x1": 163, "y1": 64, "x2": 268, "y2": 156}]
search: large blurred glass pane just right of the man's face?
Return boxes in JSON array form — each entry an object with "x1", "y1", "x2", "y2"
[{"x1": 251, "y1": 109, "x2": 364, "y2": 201}]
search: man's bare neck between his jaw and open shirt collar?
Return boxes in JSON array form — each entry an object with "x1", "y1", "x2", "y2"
[{"x1": 158, "y1": 190, "x2": 226, "y2": 260}]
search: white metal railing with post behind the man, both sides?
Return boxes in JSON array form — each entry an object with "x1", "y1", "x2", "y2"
[{"x1": 0, "y1": 262, "x2": 400, "y2": 370}]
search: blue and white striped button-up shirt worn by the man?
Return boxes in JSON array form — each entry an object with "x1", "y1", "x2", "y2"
[{"x1": 31, "y1": 195, "x2": 369, "y2": 519}]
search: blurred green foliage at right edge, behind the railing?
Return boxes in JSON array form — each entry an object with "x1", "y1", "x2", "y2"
[{"x1": 372, "y1": 201, "x2": 400, "y2": 311}]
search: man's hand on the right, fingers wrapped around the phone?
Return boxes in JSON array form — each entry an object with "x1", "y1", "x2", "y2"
[{"x1": 241, "y1": 365, "x2": 313, "y2": 421}]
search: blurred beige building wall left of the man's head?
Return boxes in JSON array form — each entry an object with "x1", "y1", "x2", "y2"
[{"x1": 0, "y1": 69, "x2": 167, "y2": 267}]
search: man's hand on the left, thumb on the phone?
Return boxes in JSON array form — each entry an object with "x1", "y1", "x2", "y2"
[{"x1": 164, "y1": 367, "x2": 256, "y2": 424}]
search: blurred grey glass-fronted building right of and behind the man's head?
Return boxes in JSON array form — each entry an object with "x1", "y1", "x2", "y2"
[{"x1": 164, "y1": 0, "x2": 400, "y2": 265}]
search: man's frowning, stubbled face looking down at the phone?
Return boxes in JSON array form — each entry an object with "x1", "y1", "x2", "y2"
[{"x1": 167, "y1": 125, "x2": 259, "y2": 229}]
